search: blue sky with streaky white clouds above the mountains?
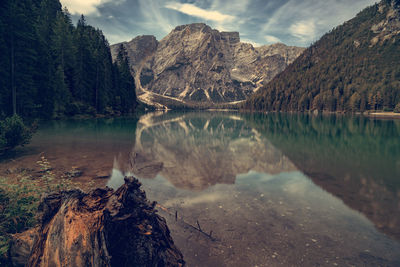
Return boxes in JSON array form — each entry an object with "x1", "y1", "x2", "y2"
[{"x1": 61, "y1": 0, "x2": 376, "y2": 47}]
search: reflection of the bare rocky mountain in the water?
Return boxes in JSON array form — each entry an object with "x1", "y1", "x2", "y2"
[{"x1": 116, "y1": 113, "x2": 296, "y2": 191}]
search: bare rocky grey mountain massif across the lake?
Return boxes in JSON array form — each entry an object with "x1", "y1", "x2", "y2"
[{"x1": 111, "y1": 23, "x2": 304, "y2": 108}]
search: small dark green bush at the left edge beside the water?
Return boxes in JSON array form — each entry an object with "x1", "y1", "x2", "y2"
[{"x1": 0, "y1": 115, "x2": 33, "y2": 152}]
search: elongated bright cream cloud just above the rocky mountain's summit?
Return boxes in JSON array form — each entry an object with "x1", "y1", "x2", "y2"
[{"x1": 165, "y1": 3, "x2": 235, "y2": 22}]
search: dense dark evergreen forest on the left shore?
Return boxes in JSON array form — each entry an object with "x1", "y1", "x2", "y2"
[{"x1": 0, "y1": 0, "x2": 136, "y2": 118}]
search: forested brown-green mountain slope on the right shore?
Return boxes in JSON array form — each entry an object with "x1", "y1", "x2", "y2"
[{"x1": 244, "y1": 0, "x2": 400, "y2": 111}]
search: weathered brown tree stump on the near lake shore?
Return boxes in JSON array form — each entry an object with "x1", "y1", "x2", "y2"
[{"x1": 10, "y1": 178, "x2": 184, "y2": 266}]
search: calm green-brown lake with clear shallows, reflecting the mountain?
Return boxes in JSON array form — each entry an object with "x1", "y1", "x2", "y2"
[{"x1": 0, "y1": 111, "x2": 400, "y2": 266}]
